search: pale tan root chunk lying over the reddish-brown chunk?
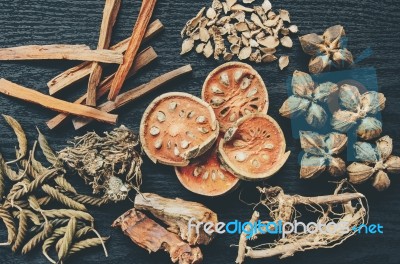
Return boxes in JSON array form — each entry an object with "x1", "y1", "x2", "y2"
[{"x1": 135, "y1": 193, "x2": 218, "y2": 246}]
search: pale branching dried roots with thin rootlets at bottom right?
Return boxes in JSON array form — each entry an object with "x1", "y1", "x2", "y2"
[{"x1": 236, "y1": 181, "x2": 368, "y2": 263}]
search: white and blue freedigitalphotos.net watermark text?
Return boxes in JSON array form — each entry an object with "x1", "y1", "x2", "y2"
[{"x1": 188, "y1": 218, "x2": 383, "y2": 239}]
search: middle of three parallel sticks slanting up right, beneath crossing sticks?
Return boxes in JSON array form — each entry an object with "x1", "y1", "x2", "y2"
[{"x1": 47, "y1": 47, "x2": 157, "y2": 129}]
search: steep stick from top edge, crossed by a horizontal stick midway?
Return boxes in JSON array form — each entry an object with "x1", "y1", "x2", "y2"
[{"x1": 86, "y1": 0, "x2": 121, "y2": 106}]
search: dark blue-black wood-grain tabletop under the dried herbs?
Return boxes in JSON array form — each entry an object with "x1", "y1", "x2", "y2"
[{"x1": 0, "y1": 0, "x2": 400, "y2": 264}]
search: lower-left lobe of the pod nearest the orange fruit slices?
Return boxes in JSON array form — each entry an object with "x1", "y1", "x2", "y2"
[{"x1": 300, "y1": 153, "x2": 326, "y2": 179}]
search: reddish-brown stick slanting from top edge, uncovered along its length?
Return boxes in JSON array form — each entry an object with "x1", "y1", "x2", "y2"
[{"x1": 108, "y1": 0, "x2": 157, "y2": 101}]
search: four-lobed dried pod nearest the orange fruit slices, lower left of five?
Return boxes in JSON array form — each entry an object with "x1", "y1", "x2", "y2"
[{"x1": 300, "y1": 131, "x2": 347, "y2": 179}]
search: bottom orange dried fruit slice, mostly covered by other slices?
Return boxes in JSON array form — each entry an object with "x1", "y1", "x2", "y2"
[{"x1": 175, "y1": 138, "x2": 239, "y2": 196}]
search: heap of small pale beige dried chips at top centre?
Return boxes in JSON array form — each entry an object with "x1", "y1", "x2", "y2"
[{"x1": 181, "y1": 0, "x2": 298, "y2": 69}]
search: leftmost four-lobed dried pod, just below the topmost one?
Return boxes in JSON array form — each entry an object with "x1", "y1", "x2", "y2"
[{"x1": 279, "y1": 71, "x2": 339, "y2": 128}]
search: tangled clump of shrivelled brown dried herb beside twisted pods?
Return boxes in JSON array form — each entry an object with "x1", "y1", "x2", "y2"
[{"x1": 58, "y1": 126, "x2": 142, "y2": 202}]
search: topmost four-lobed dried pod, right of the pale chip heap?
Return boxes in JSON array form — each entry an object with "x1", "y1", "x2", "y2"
[{"x1": 300, "y1": 25, "x2": 353, "y2": 74}]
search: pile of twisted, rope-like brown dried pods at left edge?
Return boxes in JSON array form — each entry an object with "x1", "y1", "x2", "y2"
[{"x1": 0, "y1": 116, "x2": 108, "y2": 263}]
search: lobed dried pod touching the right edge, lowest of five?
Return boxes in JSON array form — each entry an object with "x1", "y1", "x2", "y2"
[{"x1": 347, "y1": 136, "x2": 400, "y2": 191}]
